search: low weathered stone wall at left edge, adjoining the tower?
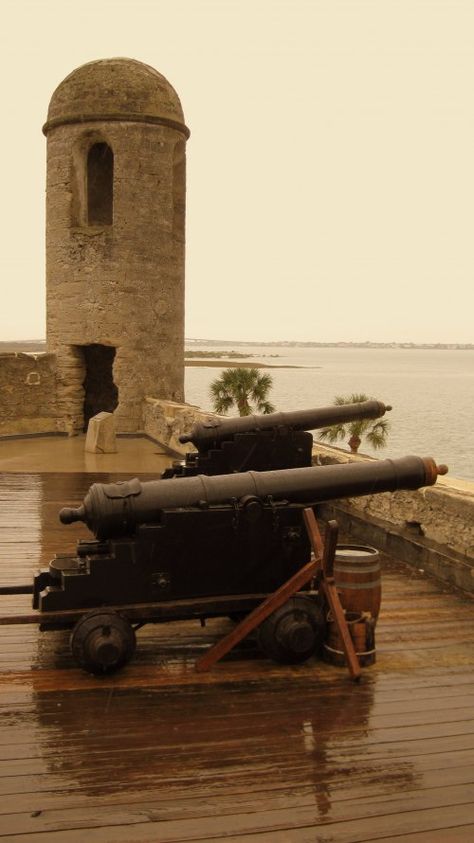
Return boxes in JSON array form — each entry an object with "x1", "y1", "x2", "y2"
[{"x1": 0, "y1": 354, "x2": 57, "y2": 435}]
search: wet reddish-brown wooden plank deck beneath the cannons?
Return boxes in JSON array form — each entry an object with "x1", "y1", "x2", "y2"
[{"x1": 0, "y1": 473, "x2": 474, "y2": 843}]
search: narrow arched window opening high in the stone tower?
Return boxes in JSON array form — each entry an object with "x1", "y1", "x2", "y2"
[{"x1": 87, "y1": 143, "x2": 114, "y2": 225}]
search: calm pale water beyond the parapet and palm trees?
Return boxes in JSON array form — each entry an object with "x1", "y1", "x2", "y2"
[{"x1": 186, "y1": 345, "x2": 474, "y2": 480}]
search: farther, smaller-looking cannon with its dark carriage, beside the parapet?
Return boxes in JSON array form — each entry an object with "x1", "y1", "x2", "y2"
[{"x1": 162, "y1": 400, "x2": 391, "y2": 479}]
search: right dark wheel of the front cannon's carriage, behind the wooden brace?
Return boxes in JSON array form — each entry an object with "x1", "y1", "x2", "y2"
[{"x1": 258, "y1": 595, "x2": 326, "y2": 664}]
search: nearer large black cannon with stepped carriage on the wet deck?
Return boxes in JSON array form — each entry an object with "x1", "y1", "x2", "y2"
[{"x1": 26, "y1": 456, "x2": 445, "y2": 672}]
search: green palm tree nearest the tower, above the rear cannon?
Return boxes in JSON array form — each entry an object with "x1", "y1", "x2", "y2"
[{"x1": 210, "y1": 368, "x2": 275, "y2": 416}]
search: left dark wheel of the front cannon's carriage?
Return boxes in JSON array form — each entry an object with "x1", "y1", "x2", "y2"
[{"x1": 71, "y1": 610, "x2": 136, "y2": 675}]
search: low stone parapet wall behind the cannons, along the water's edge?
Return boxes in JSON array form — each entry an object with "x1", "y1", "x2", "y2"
[{"x1": 144, "y1": 398, "x2": 474, "y2": 592}]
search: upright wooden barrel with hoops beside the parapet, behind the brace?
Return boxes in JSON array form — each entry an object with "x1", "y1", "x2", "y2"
[{"x1": 334, "y1": 544, "x2": 382, "y2": 621}]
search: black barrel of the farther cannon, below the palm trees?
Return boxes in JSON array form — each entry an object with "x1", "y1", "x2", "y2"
[{"x1": 179, "y1": 401, "x2": 392, "y2": 450}]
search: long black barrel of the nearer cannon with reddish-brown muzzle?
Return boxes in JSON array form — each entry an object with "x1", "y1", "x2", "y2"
[{"x1": 59, "y1": 456, "x2": 447, "y2": 539}]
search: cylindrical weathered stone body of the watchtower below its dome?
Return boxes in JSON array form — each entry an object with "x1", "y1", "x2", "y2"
[{"x1": 46, "y1": 123, "x2": 184, "y2": 432}]
